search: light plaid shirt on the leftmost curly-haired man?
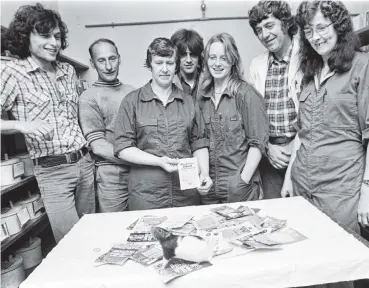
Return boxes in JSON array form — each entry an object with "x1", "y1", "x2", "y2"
[{"x1": 1, "y1": 57, "x2": 86, "y2": 159}]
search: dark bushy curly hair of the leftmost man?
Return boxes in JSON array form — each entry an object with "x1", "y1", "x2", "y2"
[{"x1": 5, "y1": 3, "x2": 68, "y2": 59}]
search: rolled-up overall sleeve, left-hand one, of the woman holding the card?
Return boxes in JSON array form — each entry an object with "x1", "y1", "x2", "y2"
[{"x1": 114, "y1": 92, "x2": 137, "y2": 157}]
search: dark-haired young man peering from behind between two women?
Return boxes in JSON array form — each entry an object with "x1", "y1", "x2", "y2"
[{"x1": 170, "y1": 29, "x2": 204, "y2": 99}]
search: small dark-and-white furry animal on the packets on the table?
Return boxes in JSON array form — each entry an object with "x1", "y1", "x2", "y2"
[{"x1": 151, "y1": 227, "x2": 213, "y2": 269}]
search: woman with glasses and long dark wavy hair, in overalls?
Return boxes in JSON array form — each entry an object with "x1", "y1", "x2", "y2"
[{"x1": 282, "y1": 1, "x2": 369, "y2": 236}]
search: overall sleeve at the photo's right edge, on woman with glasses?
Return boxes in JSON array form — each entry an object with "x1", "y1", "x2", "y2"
[{"x1": 357, "y1": 61, "x2": 369, "y2": 147}]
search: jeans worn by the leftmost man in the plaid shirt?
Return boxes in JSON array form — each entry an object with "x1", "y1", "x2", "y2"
[{"x1": 34, "y1": 154, "x2": 95, "y2": 243}]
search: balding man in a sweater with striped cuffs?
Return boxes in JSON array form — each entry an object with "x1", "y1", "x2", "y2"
[{"x1": 79, "y1": 38, "x2": 134, "y2": 212}]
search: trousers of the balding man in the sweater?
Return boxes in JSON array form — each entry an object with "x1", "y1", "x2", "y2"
[{"x1": 96, "y1": 165, "x2": 129, "y2": 212}]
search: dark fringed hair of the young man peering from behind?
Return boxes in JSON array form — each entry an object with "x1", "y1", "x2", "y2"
[{"x1": 170, "y1": 29, "x2": 204, "y2": 72}]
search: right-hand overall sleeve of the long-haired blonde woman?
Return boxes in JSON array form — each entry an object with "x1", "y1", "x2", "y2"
[{"x1": 237, "y1": 85, "x2": 269, "y2": 155}]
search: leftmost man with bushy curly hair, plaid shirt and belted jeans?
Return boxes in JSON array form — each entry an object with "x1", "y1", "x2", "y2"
[{"x1": 1, "y1": 4, "x2": 95, "y2": 242}]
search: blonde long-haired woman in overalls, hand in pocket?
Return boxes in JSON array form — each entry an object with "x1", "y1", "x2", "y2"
[{"x1": 198, "y1": 33, "x2": 269, "y2": 204}]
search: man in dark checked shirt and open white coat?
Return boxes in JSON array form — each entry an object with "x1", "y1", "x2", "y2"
[{"x1": 249, "y1": 1, "x2": 302, "y2": 199}]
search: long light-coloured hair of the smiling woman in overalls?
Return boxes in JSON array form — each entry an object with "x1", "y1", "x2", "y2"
[{"x1": 200, "y1": 33, "x2": 246, "y2": 96}]
